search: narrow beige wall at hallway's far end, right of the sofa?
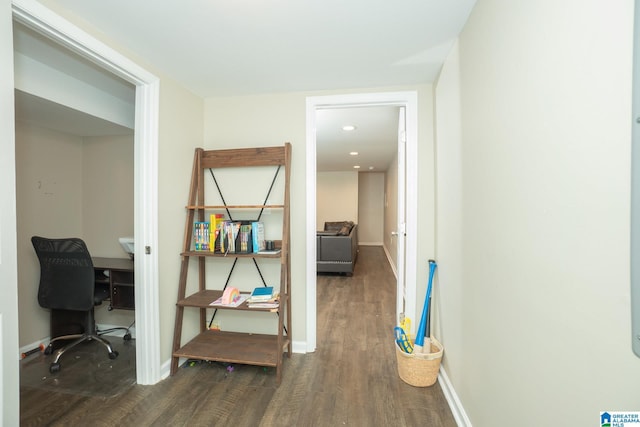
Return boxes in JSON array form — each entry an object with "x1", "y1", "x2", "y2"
[{"x1": 357, "y1": 172, "x2": 385, "y2": 246}]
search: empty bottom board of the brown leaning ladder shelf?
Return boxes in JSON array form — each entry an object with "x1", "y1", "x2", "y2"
[{"x1": 173, "y1": 331, "x2": 289, "y2": 367}]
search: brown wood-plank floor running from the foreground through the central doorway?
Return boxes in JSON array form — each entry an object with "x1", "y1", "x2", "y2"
[{"x1": 20, "y1": 246, "x2": 456, "y2": 427}]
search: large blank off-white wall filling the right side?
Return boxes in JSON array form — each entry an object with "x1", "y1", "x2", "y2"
[{"x1": 437, "y1": 0, "x2": 640, "y2": 426}]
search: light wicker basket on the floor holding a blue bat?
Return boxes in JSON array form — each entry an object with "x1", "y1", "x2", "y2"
[{"x1": 396, "y1": 338, "x2": 444, "y2": 387}]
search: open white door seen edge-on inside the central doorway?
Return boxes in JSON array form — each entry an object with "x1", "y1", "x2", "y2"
[{"x1": 394, "y1": 107, "x2": 409, "y2": 326}]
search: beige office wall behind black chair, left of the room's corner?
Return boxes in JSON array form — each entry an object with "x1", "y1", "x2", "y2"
[{"x1": 16, "y1": 123, "x2": 83, "y2": 346}]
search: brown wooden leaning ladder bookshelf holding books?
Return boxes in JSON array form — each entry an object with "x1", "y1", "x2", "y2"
[{"x1": 171, "y1": 143, "x2": 292, "y2": 384}]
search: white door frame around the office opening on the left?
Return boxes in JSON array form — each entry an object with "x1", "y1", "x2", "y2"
[{"x1": 12, "y1": 0, "x2": 161, "y2": 384}]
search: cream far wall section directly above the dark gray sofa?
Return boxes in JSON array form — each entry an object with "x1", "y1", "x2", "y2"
[{"x1": 316, "y1": 172, "x2": 359, "y2": 230}]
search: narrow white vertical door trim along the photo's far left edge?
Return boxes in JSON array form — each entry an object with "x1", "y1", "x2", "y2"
[{"x1": 0, "y1": 0, "x2": 20, "y2": 426}]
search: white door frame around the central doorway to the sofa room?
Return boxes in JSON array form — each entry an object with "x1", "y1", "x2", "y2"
[{"x1": 305, "y1": 91, "x2": 418, "y2": 352}]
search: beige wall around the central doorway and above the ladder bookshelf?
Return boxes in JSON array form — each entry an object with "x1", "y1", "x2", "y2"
[{"x1": 204, "y1": 85, "x2": 434, "y2": 346}]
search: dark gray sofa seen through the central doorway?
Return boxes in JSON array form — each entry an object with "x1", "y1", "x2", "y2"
[{"x1": 316, "y1": 221, "x2": 358, "y2": 276}]
